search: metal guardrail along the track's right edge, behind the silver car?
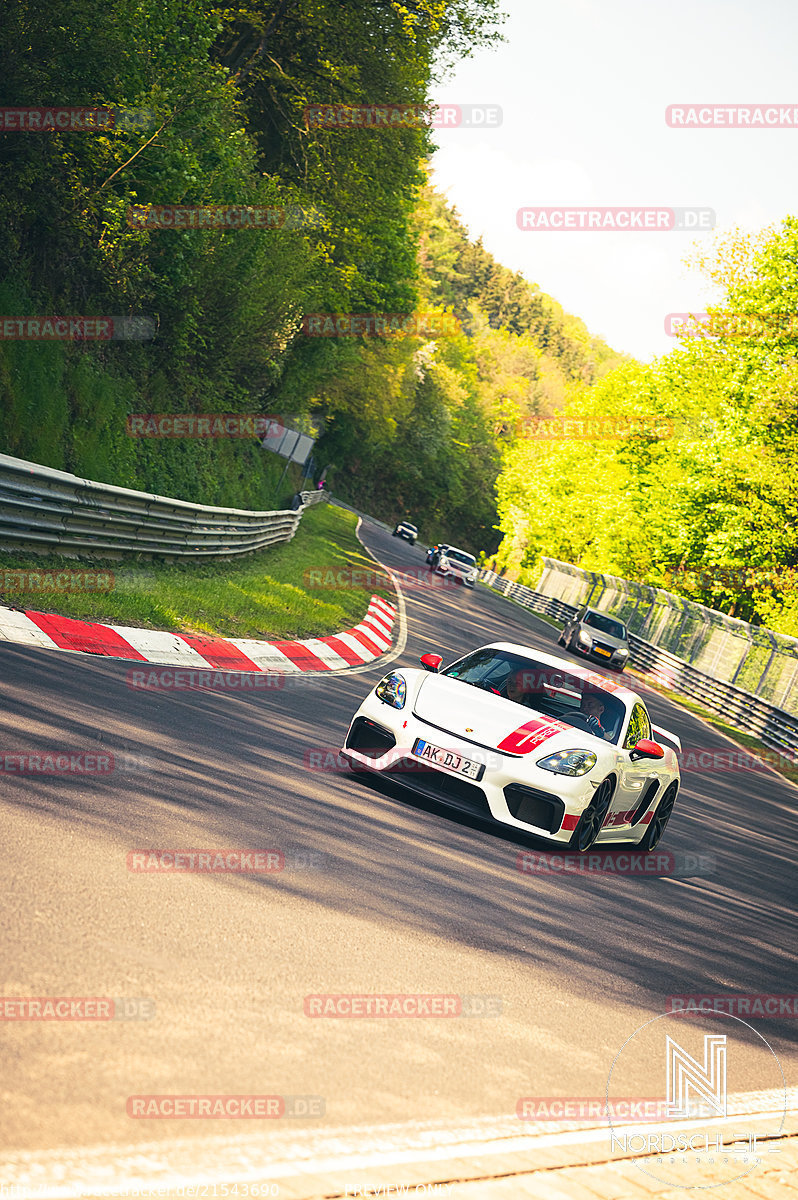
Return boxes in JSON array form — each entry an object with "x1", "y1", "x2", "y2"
[{"x1": 479, "y1": 570, "x2": 798, "y2": 761}]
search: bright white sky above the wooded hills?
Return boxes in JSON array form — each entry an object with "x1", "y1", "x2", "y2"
[{"x1": 432, "y1": 0, "x2": 798, "y2": 360}]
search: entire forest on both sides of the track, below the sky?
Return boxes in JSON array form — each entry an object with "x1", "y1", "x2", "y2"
[{"x1": 0, "y1": 0, "x2": 798, "y2": 631}]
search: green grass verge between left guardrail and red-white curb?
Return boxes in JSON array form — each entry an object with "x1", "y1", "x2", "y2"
[{"x1": 0, "y1": 504, "x2": 395, "y2": 638}]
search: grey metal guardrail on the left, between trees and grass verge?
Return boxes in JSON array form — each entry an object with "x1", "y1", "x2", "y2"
[{"x1": 0, "y1": 455, "x2": 328, "y2": 558}]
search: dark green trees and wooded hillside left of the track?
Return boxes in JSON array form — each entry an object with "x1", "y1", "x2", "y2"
[{"x1": 0, "y1": 0, "x2": 604, "y2": 550}]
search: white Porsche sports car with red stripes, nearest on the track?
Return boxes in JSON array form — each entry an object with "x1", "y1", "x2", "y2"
[{"x1": 341, "y1": 642, "x2": 682, "y2": 852}]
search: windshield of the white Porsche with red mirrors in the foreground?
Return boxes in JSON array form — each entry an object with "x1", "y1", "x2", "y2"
[{"x1": 442, "y1": 648, "x2": 626, "y2": 744}]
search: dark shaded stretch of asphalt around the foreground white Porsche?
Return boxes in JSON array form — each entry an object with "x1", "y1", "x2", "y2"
[{"x1": 0, "y1": 528, "x2": 798, "y2": 1040}]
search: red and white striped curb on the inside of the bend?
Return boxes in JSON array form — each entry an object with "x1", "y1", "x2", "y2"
[{"x1": 0, "y1": 596, "x2": 396, "y2": 674}]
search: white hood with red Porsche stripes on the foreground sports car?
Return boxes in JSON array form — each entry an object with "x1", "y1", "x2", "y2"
[{"x1": 413, "y1": 674, "x2": 608, "y2": 756}]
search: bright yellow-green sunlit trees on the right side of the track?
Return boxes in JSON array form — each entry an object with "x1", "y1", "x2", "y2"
[{"x1": 499, "y1": 224, "x2": 798, "y2": 634}]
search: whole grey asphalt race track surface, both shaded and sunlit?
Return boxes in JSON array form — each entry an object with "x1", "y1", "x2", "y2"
[{"x1": 0, "y1": 523, "x2": 798, "y2": 1150}]
